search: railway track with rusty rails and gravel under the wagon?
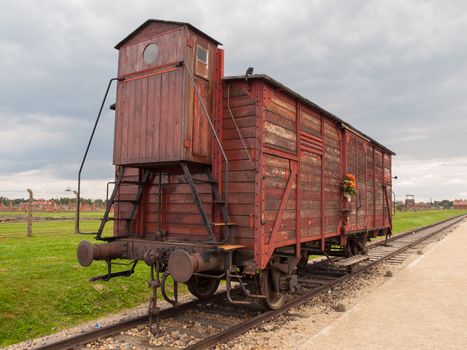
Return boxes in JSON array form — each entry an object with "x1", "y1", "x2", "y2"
[{"x1": 34, "y1": 215, "x2": 467, "y2": 350}]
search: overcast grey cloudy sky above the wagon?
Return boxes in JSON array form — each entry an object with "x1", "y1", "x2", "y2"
[{"x1": 0, "y1": 0, "x2": 467, "y2": 200}]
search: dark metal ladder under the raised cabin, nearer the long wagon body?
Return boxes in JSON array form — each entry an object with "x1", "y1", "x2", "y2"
[{"x1": 180, "y1": 162, "x2": 235, "y2": 244}]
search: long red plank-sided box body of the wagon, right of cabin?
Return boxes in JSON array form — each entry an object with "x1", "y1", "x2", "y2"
[{"x1": 222, "y1": 75, "x2": 393, "y2": 269}]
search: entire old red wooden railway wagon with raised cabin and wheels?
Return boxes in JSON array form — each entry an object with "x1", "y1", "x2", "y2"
[{"x1": 78, "y1": 20, "x2": 394, "y2": 310}]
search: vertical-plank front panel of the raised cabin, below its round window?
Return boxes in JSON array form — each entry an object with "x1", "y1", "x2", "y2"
[{"x1": 114, "y1": 69, "x2": 184, "y2": 165}]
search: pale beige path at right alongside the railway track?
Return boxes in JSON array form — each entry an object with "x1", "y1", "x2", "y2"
[{"x1": 299, "y1": 222, "x2": 467, "y2": 350}]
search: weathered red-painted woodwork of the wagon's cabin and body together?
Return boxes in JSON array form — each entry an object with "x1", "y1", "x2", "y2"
[{"x1": 110, "y1": 21, "x2": 392, "y2": 269}]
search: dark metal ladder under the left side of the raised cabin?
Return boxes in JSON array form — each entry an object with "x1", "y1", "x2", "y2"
[{"x1": 96, "y1": 166, "x2": 151, "y2": 241}]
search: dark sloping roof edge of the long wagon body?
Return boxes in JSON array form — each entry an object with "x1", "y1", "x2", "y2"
[{"x1": 224, "y1": 74, "x2": 396, "y2": 155}]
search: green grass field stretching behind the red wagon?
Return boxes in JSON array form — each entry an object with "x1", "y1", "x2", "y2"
[{"x1": 0, "y1": 210, "x2": 465, "y2": 346}]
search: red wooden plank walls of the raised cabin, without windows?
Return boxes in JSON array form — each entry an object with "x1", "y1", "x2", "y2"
[{"x1": 114, "y1": 23, "x2": 217, "y2": 165}]
